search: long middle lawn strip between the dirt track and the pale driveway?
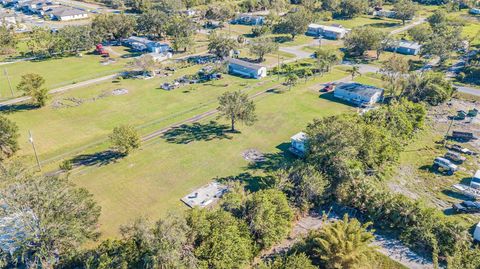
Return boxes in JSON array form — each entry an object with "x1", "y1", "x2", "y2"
[{"x1": 7, "y1": 66, "x2": 280, "y2": 163}]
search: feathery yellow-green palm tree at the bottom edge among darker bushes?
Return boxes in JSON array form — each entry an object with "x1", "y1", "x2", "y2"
[{"x1": 307, "y1": 214, "x2": 374, "y2": 268}]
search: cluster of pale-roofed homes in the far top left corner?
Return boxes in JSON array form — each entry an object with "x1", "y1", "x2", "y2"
[{"x1": 1, "y1": 0, "x2": 88, "y2": 21}]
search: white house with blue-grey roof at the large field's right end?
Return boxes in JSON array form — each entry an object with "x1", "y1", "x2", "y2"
[{"x1": 334, "y1": 82, "x2": 383, "y2": 106}]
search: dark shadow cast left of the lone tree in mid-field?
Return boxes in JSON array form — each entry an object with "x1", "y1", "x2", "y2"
[{"x1": 162, "y1": 121, "x2": 231, "y2": 144}]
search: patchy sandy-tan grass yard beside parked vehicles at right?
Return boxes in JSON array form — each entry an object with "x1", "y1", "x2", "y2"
[{"x1": 388, "y1": 116, "x2": 480, "y2": 225}]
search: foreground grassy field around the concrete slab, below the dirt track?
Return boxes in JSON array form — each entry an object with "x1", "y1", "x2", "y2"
[{"x1": 59, "y1": 71, "x2": 348, "y2": 236}]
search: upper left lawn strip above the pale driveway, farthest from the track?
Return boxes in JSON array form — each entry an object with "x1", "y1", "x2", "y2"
[{"x1": 0, "y1": 52, "x2": 127, "y2": 99}]
